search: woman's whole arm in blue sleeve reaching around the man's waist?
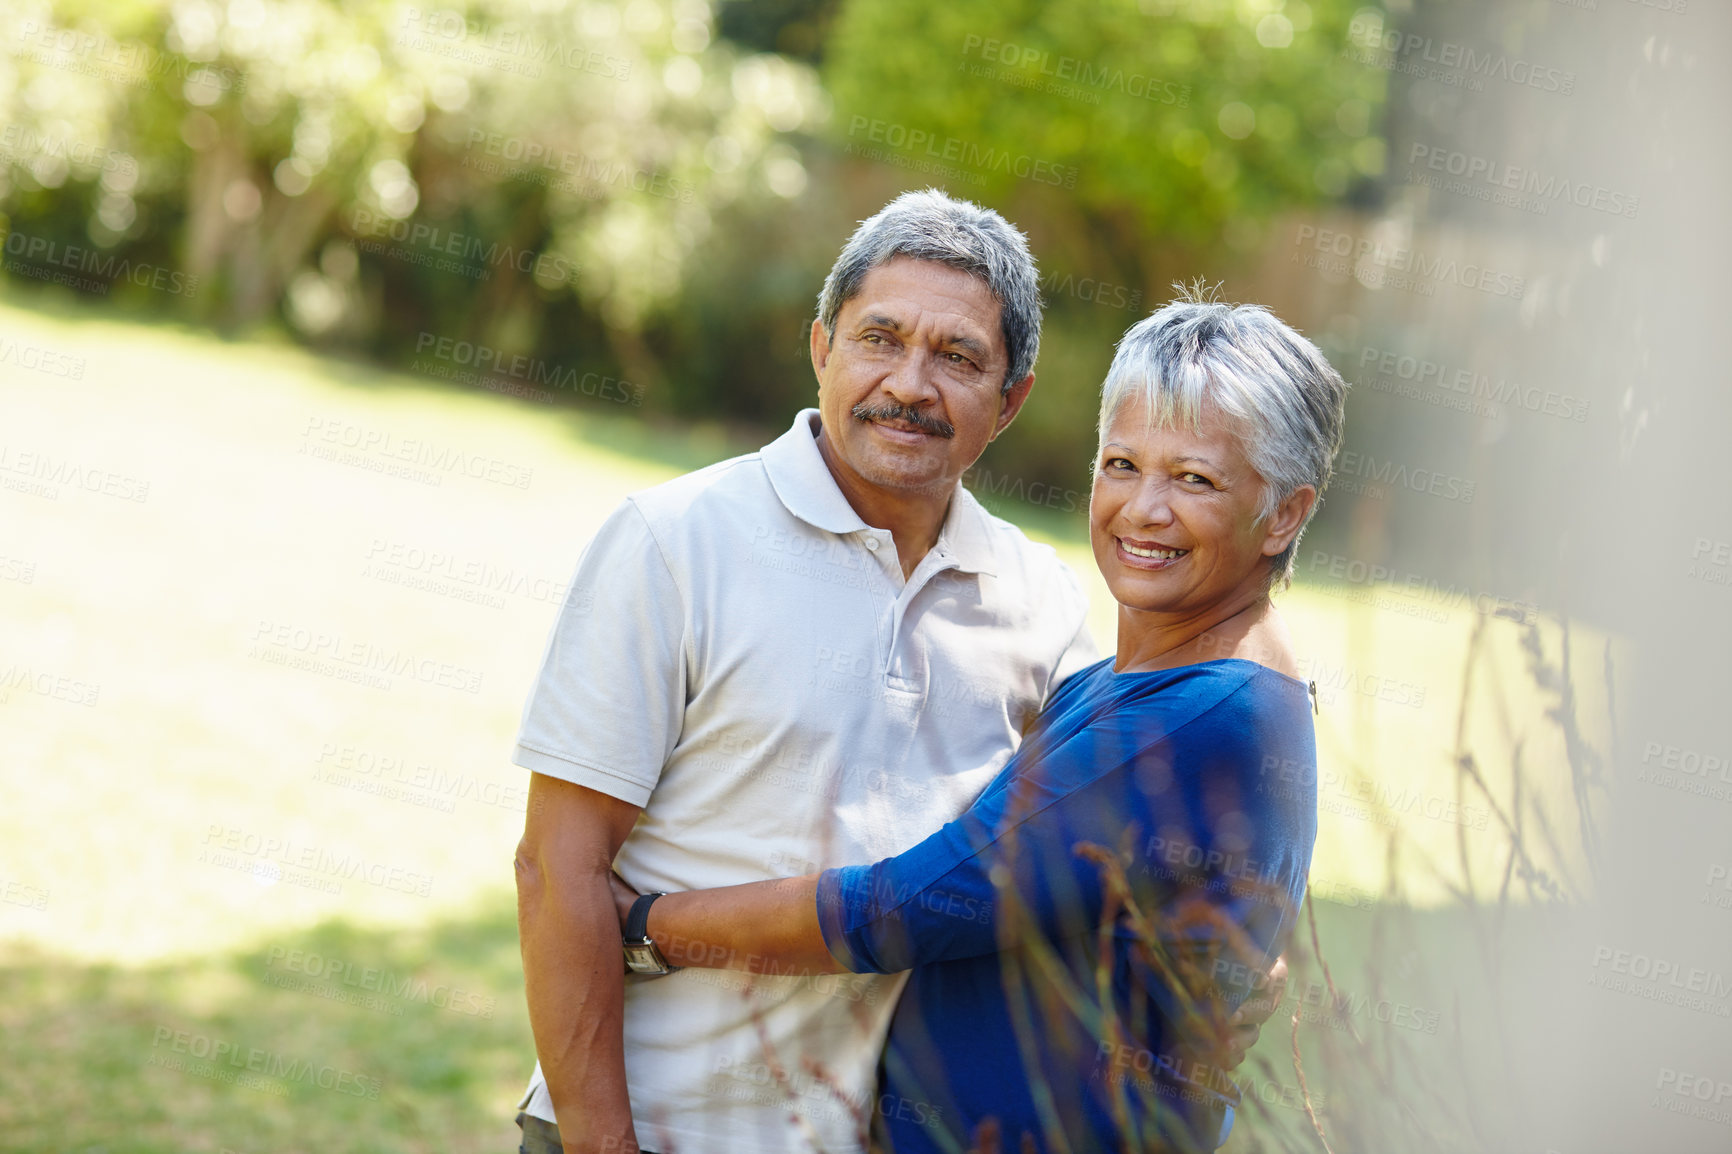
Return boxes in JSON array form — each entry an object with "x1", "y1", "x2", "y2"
[{"x1": 617, "y1": 677, "x2": 1316, "y2": 984}]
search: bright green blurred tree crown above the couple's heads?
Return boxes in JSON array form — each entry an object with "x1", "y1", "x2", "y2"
[{"x1": 826, "y1": 0, "x2": 1384, "y2": 249}]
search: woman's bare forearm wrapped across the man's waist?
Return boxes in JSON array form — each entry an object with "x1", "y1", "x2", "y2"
[{"x1": 613, "y1": 873, "x2": 847, "y2": 974}]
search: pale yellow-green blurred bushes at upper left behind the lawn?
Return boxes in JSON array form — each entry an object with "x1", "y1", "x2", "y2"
[{"x1": 0, "y1": 0, "x2": 823, "y2": 364}]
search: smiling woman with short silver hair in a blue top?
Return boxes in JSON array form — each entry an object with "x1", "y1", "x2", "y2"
[{"x1": 617, "y1": 295, "x2": 1346, "y2": 1154}]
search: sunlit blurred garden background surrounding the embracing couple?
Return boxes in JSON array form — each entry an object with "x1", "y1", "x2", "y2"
[{"x1": 0, "y1": 0, "x2": 1732, "y2": 1154}]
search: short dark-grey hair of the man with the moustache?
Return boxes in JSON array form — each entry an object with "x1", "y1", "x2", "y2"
[{"x1": 818, "y1": 189, "x2": 1041, "y2": 392}]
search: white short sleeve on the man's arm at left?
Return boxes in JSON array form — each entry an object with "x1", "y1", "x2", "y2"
[{"x1": 513, "y1": 501, "x2": 686, "y2": 807}]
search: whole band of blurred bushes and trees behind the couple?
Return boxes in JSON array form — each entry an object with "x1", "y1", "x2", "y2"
[{"x1": 0, "y1": 0, "x2": 1386, "y2": 481}]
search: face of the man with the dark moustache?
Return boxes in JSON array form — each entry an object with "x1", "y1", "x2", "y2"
[{"x1": 812, "y1": 256, "x2": 1034, "y2": 496}]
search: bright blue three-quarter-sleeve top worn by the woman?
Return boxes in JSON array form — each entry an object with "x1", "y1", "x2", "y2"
[{"x1": 818, "y1": 658, "x2": 1316, "y2": 1154}]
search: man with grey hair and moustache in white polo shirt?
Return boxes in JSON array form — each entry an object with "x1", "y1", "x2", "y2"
[{"x1": 514, "y1": 191, "x2": 1274, "y2": 1154}]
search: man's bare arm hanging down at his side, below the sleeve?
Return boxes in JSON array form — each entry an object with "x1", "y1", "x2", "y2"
[{"x1": 516, "y1": 773, "x2": 639, "y2": 1154}]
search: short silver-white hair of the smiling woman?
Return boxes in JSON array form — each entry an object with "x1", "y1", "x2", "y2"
[{"x1": 1098, "y1": 286, "x2": 1347, "y2": 587}]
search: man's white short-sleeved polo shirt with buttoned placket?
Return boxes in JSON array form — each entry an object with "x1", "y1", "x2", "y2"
[{"x1": 513, "y1": 409, "x2": 1096, "y2": 1154}]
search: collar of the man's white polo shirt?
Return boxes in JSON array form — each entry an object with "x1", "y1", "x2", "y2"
[{"x1": 759, "y1": 409, "x2": 998, "y2": 577}]
